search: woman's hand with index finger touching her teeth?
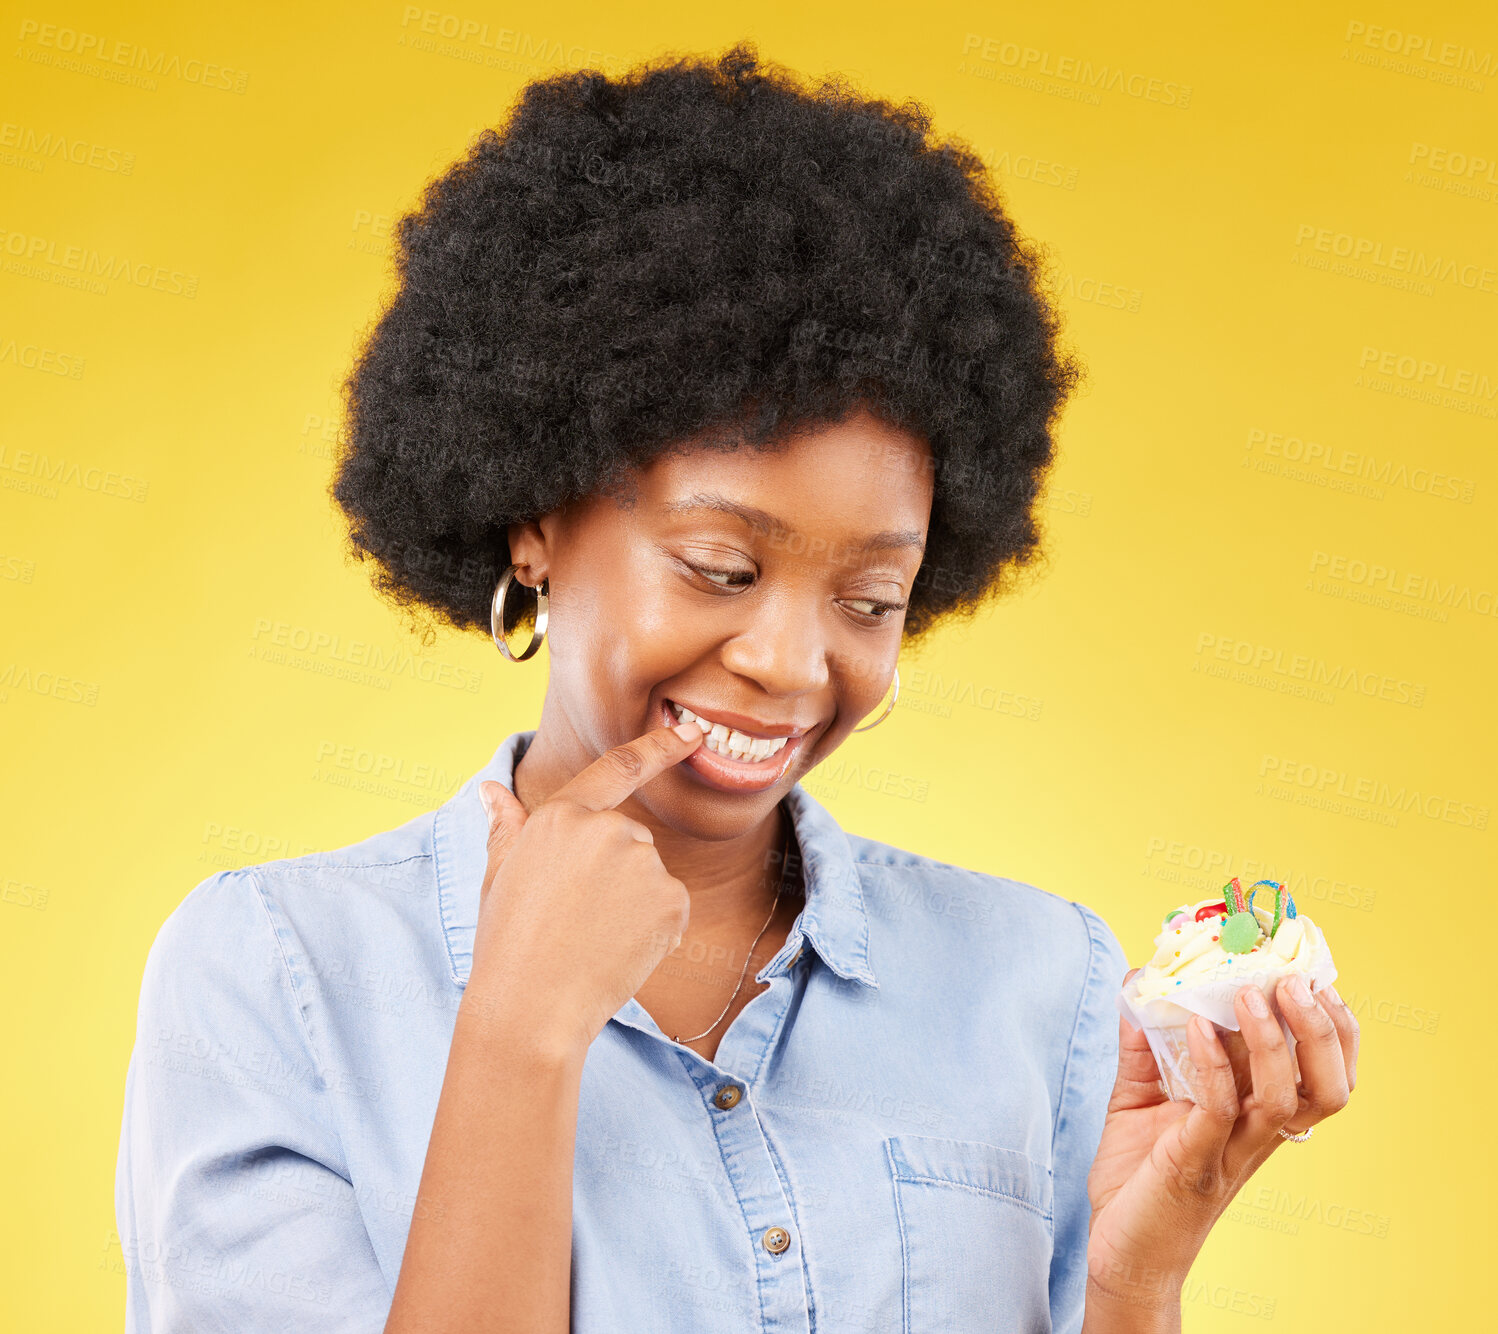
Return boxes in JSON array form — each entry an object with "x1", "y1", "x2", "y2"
[{"x1": 464, "y1": 725, "x2": 703, "y2": 1056}]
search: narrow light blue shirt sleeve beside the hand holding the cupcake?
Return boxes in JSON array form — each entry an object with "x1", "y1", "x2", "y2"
[{"x1": 1050, "y1": 903, "x2": 1128, "y2": 1334}]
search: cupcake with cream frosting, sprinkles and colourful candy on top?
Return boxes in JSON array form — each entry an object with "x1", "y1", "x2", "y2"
[{"x1": 1118, "y1": 876, "x2": 1336, "y2": 1102}]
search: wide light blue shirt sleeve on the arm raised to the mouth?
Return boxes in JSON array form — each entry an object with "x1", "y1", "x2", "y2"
[{"x1": 115, "y1": 871, "x2": 391, "y2": 1334}]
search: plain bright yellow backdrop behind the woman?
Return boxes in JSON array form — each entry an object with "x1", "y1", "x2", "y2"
[{"x1": 0, "y1": 0, "x2": 1498, "y2": 1331}]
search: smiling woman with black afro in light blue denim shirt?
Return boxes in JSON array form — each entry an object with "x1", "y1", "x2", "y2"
[{"x1": 117, "y1": 46, "x2": 1357, "y2": 1334}]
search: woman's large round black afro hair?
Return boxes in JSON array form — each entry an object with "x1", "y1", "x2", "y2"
[{"x1": 330, "y1": 42, "x2": 1082, "y2": 644}]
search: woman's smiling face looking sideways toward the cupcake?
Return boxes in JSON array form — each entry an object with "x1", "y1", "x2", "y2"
[{"x1": 509, "y1": 412, "x2": 932, "y2": 838}]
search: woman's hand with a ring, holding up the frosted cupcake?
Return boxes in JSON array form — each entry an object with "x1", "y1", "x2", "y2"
[{"x1": 1088, "y1": 969, "x2": 1359, "y2": 1313}]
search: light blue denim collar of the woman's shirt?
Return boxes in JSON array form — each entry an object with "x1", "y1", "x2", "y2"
[{"x1": 431, "y1": 729, "x2": 879, "y2": 988}]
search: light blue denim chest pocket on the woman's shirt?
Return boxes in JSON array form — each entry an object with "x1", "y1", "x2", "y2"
[{"x1": 884, "y1": 1135, "x2": 1055, "y2": 1334}]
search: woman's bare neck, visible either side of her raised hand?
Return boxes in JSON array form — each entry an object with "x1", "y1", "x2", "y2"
[{"x1": 514, "y1": 711, "x2": 800, "y2": 943}]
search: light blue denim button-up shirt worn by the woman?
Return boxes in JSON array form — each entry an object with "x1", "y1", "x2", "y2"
[{"x1": 115, "y1": 731, "x2": 1126, "y2": 1334}]
